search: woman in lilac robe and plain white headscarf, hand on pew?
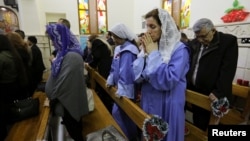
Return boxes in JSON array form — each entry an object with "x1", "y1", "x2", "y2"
[{"x1": 107, "y1": 24, "x2": 139, "y2": 140}]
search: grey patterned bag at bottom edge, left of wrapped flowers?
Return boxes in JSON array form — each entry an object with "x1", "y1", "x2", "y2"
[{"x1": 86, "y1": 125, "x2": 128, "y2": 141}]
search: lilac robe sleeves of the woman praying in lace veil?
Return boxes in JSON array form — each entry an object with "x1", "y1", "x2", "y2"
[{"x1": 133, "y1": 48, "x2": 189, "y2": 91}]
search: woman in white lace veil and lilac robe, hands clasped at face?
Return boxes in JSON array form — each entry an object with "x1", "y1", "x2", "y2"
[{"x1": 133, "y1": 9, "x2": 189, "y2": 141}]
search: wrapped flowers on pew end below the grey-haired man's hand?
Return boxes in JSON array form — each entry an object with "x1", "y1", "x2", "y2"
[{"x1": 211, "y1": 97, "x2": 229, "y2": 118}]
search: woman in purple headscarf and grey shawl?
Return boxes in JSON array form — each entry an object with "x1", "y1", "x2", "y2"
[{"x1": 45, "y1": 24, "x2": 89, "y2": 141}]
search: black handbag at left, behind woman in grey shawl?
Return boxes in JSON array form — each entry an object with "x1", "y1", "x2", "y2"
[{"x1": 10, "y1": 97, "x2": 40, "y2": 122}]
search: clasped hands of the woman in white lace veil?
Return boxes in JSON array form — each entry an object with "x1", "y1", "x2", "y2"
[{"x1": 141, "y1": 33, "x2": 158, "y2": 54}]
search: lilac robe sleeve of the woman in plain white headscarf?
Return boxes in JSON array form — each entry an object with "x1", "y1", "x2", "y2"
[{"x1": 116, "y1": 51, "x2": 136, "y2": 99}]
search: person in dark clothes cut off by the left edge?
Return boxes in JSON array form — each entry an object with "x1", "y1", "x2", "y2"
[{"x1": 0, "y1": 34, "x2": 28, "y2": 141}]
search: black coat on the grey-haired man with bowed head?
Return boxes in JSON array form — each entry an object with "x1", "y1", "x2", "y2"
[{"x1": 187, "y1": 31, "x2": 238, "y2": 101}]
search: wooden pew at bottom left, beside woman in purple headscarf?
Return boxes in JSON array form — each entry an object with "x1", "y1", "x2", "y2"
[{"x1": 5, "y1": 91, "x2": 50, "y2": 141}]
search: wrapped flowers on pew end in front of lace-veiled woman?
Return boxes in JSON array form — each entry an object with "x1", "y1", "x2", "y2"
[{"x1": 142, "y1": 115, "x2": 168, "y2": 141}]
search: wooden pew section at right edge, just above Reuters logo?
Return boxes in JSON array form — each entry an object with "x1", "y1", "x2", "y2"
[{"x1": 220, "y1": 84, "x2": 250, "y2": 125}]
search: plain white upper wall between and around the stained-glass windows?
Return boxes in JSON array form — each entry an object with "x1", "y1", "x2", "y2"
[{"x1": 0, "y1": 0, "x2": 250, "y2": 35}]
